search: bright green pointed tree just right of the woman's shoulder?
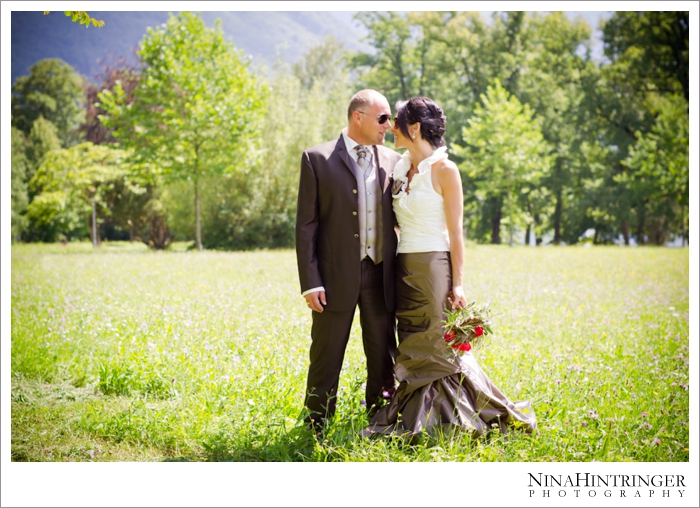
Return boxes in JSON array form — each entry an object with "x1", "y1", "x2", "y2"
[{"x1": 452, "y1": 80, "x2": 551, "y2": 245}]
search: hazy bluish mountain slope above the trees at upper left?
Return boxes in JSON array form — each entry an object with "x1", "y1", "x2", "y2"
[{"x1": 11, "y1": 11, "x2": 371, "y2": 82}]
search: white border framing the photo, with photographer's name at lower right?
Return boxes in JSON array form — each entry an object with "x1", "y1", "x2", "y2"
[{"x1": 0, "y1": 1, "x2": 700, "y2": 506}]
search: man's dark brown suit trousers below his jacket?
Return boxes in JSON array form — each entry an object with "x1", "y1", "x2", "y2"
[{"x1": 304, "y1": 258, "x2": 396, "y2": 424}]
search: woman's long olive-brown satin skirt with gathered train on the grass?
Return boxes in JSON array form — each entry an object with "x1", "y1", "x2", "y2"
[{"x1": 365, "y1": 252, "x2": 537, "y2": 435}]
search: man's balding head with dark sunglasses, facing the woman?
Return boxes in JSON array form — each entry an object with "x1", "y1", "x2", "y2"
[{"x1": 348, "y1": 90, "x2": 391, "y2": 145}]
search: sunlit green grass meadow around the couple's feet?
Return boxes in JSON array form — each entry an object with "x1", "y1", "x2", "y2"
[{"x1": 11, "y1": 243, "x2": 689, "y2": 462}]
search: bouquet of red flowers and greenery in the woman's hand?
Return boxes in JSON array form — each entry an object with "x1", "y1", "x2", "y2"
[{"x1": 443, "y1": 302, "x2": 493, "y2": 355}]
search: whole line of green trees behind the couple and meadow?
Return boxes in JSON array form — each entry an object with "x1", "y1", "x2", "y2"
[{"x1": 12, "y1": 12, "x2": 689, "y2": 249}]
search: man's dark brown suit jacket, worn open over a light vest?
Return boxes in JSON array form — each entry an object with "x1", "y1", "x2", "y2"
[{"x1": 296, "y1": 135, "x2": 401, "y2": 312}]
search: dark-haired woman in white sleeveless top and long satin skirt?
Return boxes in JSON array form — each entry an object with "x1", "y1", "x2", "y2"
[{"x1": 363, "y1": 97, "x2": 536, "y2": 436}]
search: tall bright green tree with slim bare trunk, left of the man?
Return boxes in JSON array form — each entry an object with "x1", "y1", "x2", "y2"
[{"x1": 99, "y1": 12, "x2": 266, "y2": 250}]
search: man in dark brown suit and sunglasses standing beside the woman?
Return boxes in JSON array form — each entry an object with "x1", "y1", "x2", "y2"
[{"x1": 296, "y1": 90, "x2": 400, "y2": 427}]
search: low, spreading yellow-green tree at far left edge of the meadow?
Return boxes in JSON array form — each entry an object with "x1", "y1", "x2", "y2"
[{"x1": 27, "y1": 141, "x2": 135, "y2": 246}]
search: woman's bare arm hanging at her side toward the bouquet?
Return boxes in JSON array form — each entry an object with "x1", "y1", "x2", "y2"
[{"x1": 433, "y1": 159, "x2": 467, "y2": 309}]
